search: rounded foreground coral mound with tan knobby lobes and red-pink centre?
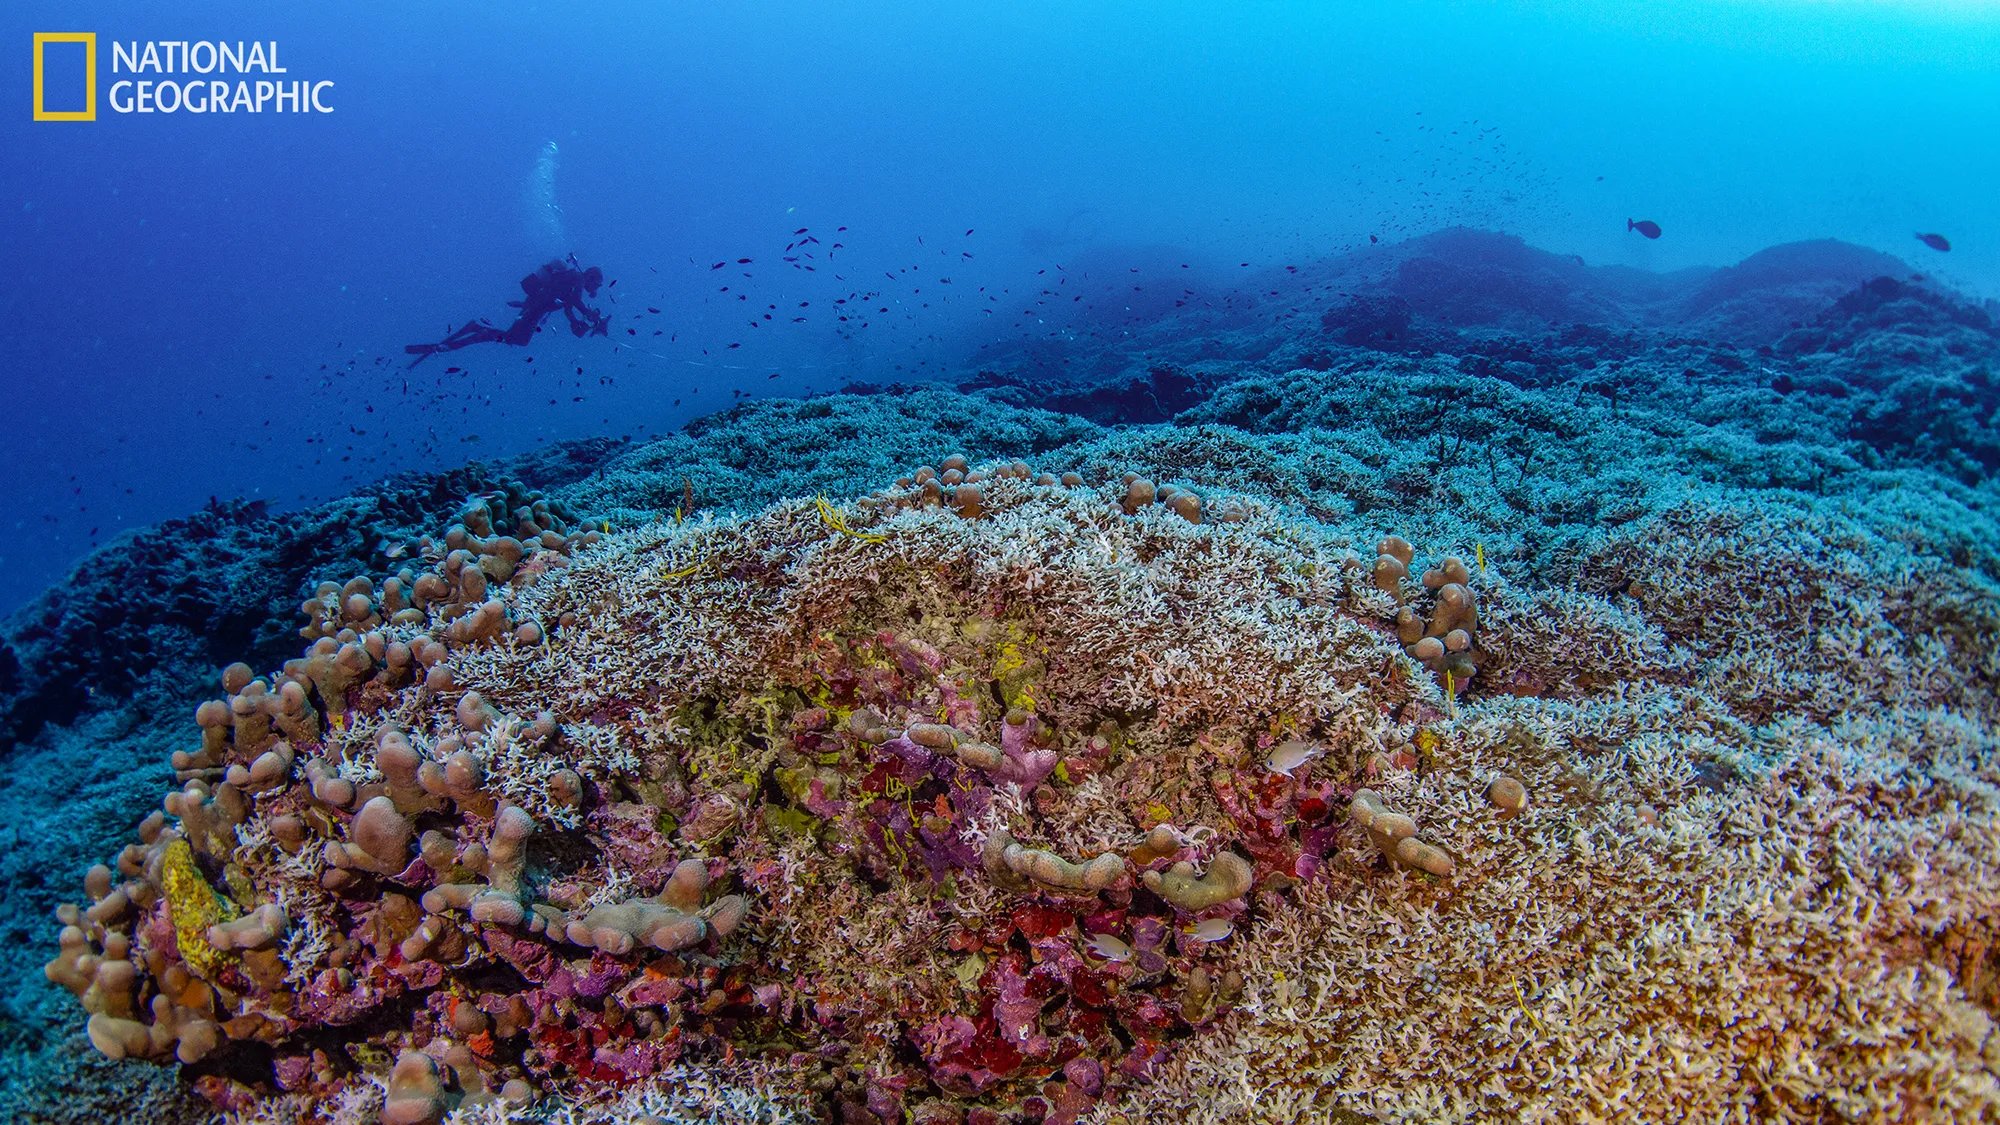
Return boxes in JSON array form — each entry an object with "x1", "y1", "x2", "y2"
[{"x1": 48, "y1": 450, "x2": 1504, "y2": 1123}]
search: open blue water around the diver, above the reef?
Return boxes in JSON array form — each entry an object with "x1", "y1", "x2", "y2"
[{"x1": 0, "y1": 0, "x2": 2000, "y2": 609}]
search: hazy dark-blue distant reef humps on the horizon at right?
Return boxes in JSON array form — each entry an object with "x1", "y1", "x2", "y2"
[{"x1": 956, "y1": 230, "x2": 2000, "y2": 472}]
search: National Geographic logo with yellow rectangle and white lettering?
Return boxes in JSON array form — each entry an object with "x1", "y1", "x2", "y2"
[{"x1": 34, "y1": 32, "x2": 334, "y2": 120}]
